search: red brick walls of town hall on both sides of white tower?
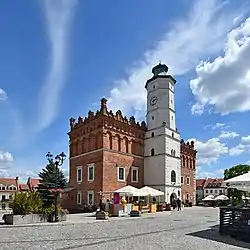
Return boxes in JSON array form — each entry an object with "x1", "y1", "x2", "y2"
[{"x1": 64, "y1": 98, "x2": 196, "y2": 209}]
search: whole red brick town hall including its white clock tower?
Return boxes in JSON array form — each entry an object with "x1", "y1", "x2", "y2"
[{"x1": 67, "y1": 64, "x2": 196, "y2": 209}]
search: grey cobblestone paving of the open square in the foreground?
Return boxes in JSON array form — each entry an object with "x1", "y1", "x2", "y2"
[{"x1": 0, "y1": 207, "x2": 250, "y2": 250}]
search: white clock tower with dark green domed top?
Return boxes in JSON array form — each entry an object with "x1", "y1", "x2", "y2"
[{"x1": 144, "y1": 64, "x2": 181, "y2": 203}]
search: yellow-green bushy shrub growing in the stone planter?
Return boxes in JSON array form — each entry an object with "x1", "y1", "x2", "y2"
[{"x1": 10, "y1": 192, "x2": 53, "y2": 215}]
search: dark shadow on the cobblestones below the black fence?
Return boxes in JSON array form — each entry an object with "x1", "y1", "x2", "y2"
[{"x1": 186, "y1": 225, "x2": 250, "y2": 249}]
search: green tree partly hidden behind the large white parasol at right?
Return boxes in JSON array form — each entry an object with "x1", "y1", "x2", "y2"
[{"x1": 224, "y1": 164, "x2": 250, "y2": 205}]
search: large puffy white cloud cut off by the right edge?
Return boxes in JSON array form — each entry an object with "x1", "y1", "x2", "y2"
[{"x1": 190, "y1": 18, "x2": 250, "y2": 114}]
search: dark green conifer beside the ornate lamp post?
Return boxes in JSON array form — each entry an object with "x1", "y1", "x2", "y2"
[{"x1": 38, "y1": 162, "x2": 67, "y2": 206}]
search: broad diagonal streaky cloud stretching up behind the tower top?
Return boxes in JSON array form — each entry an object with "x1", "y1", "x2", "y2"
[{"x1": 109, "y1": 0, "x2": 240, "y2": 113}]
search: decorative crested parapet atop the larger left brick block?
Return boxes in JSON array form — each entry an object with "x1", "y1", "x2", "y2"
[{"x1": 70, "y1": 98, "x2": 147, "y2": 131}]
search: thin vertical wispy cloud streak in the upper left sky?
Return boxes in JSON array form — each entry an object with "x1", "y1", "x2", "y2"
[{"x1": 38, "y1": 0, "x2": 77, "y2": 130}]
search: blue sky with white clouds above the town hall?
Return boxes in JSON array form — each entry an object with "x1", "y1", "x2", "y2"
[{"x1": 0, "y1": 0, "x2": 250, "y2": 180}]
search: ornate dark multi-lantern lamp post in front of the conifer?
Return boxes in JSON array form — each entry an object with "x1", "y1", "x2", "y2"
[{"x1": 46, "y1": 152, "x2": 66, "y2": 222}]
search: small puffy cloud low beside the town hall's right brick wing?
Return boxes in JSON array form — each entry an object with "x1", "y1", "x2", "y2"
[{"x1": 189, "y1": 138, "x2": 228, "y2": 166}]
